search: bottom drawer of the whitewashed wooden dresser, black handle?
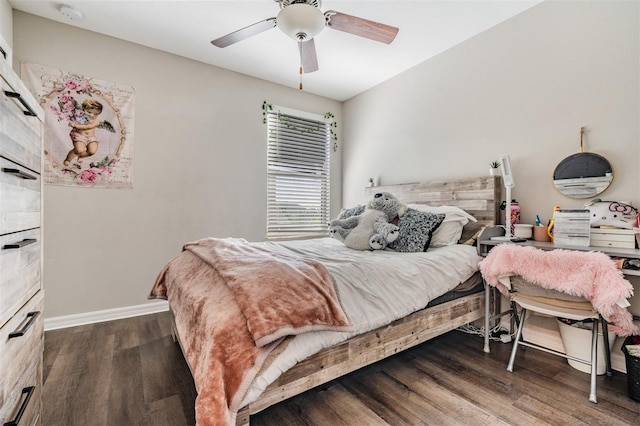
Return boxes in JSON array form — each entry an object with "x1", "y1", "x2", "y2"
[{"x1": 0, "y1": 348, "x2": 42, "y2": 426}]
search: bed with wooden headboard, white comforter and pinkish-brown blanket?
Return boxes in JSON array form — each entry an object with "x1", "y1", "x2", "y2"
[{"x1": 150, "y1": 176, "x2": 502, "y2": 426}]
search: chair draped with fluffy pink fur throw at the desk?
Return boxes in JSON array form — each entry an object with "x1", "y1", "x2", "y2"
[{"x1": 478, "y1": 227, "x2": 640, "y2": 402}]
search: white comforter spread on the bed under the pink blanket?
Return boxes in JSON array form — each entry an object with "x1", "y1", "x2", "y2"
[{"x1": 241, "y1": 238, "x2": 482, "y2": 406}]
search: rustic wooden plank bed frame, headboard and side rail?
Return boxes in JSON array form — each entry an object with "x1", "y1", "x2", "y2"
[{"x1": 231, "y1": 176, "x2": 502, "y2": 425}]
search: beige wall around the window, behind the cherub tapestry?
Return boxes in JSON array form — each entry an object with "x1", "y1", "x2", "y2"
[{"x1": 13, "y1": 11, "x2": 342, "y2": 318}]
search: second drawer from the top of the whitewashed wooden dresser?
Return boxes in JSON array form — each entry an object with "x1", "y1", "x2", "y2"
[{"x1": 0, "y1": 157, "x2": 41, "y2": 235}]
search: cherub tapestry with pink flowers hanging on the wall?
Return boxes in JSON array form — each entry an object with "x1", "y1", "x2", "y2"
[{"x1": 21, "y1": 62, "x2": 134, "y2": 189}]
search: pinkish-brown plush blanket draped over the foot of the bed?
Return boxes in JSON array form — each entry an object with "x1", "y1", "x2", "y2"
[{"x1": 149, "y1": 238, "x2": 351, "y2": 426}]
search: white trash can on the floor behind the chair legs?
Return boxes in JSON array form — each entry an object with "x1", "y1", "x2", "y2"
[{"x1": 558, "y1": 320, "x2": 616, "y2": 375}]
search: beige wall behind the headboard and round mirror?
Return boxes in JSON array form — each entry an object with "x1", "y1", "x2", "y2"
[{"x1": 343, "y1": 1, "x2": 640, "y2": 223}]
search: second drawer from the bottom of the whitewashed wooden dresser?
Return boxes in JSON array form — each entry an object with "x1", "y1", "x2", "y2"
[{"x1": 0, "y1": 292, "x2": 44, "y2": 414}]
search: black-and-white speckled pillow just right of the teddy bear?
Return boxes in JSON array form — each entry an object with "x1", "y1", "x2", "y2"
[{"x1": 388, "y1": 208, "x2": 445, "y2": 253}]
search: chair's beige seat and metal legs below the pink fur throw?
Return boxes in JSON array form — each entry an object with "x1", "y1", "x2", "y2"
[{"x1": 507, "y1": 275, "x2": 612, "y2": 403}]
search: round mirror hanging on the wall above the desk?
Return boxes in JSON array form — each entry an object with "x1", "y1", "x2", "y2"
[{"x1": 553, "y1": 152, "x2": 613, "y2": 198}]
